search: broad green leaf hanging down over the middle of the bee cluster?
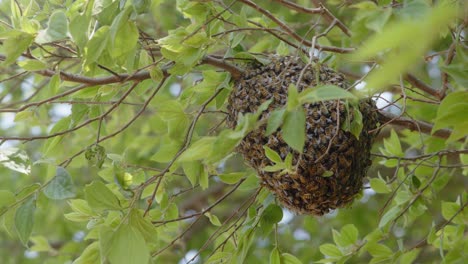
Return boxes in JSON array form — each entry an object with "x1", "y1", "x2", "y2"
[{"x1": 282, "y1": 108, "x2": 306, "y2": 153}]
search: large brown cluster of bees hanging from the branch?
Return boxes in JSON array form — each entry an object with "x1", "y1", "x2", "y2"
[{"x1": 227, "y1": 57, "x2": 377, "y2": 215}]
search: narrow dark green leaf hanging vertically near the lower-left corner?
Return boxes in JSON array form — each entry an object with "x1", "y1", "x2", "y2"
[{"x1": 15, "y1": 197, "x2": 36, "y2": 247}]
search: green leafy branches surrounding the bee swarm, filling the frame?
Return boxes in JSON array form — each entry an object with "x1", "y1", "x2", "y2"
[{"x1": 0, "y1": 0, "x2": 468, "y2": 263}]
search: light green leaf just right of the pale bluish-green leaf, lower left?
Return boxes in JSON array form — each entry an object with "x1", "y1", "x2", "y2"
[{"x1": 84, "y1": 181, "x2": 122, "y2": 211}]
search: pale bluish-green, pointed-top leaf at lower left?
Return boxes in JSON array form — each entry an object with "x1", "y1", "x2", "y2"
[{"x1": 43, "y1": 167, "x2": 75, "y2": 200}]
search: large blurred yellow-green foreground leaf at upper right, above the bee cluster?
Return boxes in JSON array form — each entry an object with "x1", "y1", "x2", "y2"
[{"x1": 353, "y1": 4, "x2": 457, "y2": 93}]
